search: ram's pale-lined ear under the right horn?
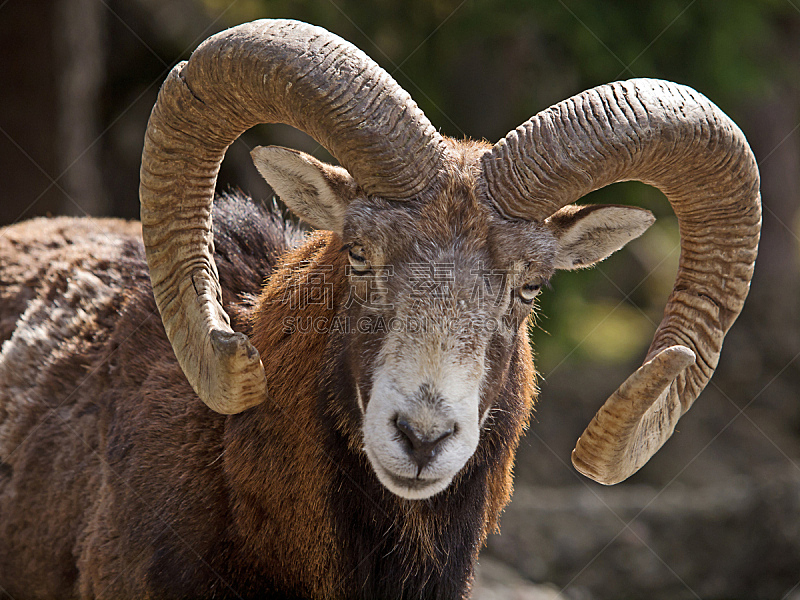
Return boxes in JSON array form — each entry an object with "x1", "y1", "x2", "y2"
[{"x1": 544, "y1": 204, "x2": 656, "y2": 269}]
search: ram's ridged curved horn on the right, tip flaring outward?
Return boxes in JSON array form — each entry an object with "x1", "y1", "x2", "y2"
[{"x1": 482, "y1": 79, "x2": 761, "y2": 484}]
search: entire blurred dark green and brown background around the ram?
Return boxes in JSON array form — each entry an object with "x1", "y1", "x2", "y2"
[{"x1": 0, "y1": 0, "x2": 800, "y2": 600}]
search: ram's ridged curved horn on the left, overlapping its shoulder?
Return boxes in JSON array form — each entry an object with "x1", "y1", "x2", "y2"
[{"x1": 139, "y1": 20, "x2": 446, "y2": 413}]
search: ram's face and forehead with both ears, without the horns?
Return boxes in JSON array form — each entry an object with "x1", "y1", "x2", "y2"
[{"x1": 254, "y1": 145, "x2": 652, "y2": 499}]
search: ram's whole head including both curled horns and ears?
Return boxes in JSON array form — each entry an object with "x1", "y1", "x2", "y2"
[{"x1": 141, "y1": 21, "x2": 760, "y2": 498}]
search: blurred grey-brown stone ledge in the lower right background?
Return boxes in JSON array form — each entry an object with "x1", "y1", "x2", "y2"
[{"x1": 476, "y1": 470, "x2": 800, "y2": 600}]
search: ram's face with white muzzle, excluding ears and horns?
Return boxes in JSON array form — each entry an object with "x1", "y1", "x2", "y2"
[{"x1": 343, "y1": 190, "x2": 555, "y2": 498}]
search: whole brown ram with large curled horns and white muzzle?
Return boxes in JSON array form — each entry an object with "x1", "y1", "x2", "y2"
[{"x1": 0, "y1": 20, "x2": 760, "y2": 600}]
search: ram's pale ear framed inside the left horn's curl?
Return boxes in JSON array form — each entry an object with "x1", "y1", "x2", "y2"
[{"x1": 250, "y1": 146, "x2": 359, "y2": 234}]
